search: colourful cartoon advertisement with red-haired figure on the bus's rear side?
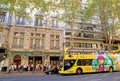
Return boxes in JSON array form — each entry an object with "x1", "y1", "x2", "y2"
[{"x1": 92, "y1": 54, "x2": 120, "y2": 72}]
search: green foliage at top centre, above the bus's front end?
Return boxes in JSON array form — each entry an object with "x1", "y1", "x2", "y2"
[{"x1": 59, "y1": 0, "x2": 81, "y2": 24}]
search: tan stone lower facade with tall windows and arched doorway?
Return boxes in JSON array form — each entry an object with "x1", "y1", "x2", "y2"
[{"x1": 4, "y1": 26, "x2": 63, "y2": 66}]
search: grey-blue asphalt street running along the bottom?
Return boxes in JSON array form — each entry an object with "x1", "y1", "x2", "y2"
[{"x1": 0, "y1": 72, "x2": 120, "y2": 81}]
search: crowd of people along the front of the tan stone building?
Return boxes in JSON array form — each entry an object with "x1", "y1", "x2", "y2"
[{"x1": 9, "y1": 63, "x2": 57, "y2": 73}]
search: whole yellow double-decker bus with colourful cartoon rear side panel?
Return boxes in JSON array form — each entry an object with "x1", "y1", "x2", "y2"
[{"x1": 59, "y1": 49, "x2": 120, "y2": 74}]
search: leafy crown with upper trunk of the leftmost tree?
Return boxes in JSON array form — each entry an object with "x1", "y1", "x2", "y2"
[{"x1": 0, "y1": 0, "x2": 30, "y2": 27}]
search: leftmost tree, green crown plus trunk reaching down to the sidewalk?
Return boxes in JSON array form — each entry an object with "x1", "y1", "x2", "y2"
[{"x1": 0, "y1": 0, "x2": 29, "y2": 70}]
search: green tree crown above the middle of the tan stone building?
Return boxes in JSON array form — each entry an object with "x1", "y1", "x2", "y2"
[{"x1": 29, "y1": 0, "x2": 57, "y2": 27}]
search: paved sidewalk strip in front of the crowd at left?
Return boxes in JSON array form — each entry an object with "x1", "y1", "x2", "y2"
[{"x1": 0, "y1": 71, "x2": 46, "y2": 76}]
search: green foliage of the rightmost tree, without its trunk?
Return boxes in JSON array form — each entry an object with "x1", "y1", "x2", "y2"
[{"x1": 84, "y1": 0, "x2": 120, "y2": 22}]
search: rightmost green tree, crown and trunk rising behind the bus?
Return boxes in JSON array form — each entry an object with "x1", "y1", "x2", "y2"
[{"x1": 84, "y1": 0, "x2": 120, "y2": 51}]
